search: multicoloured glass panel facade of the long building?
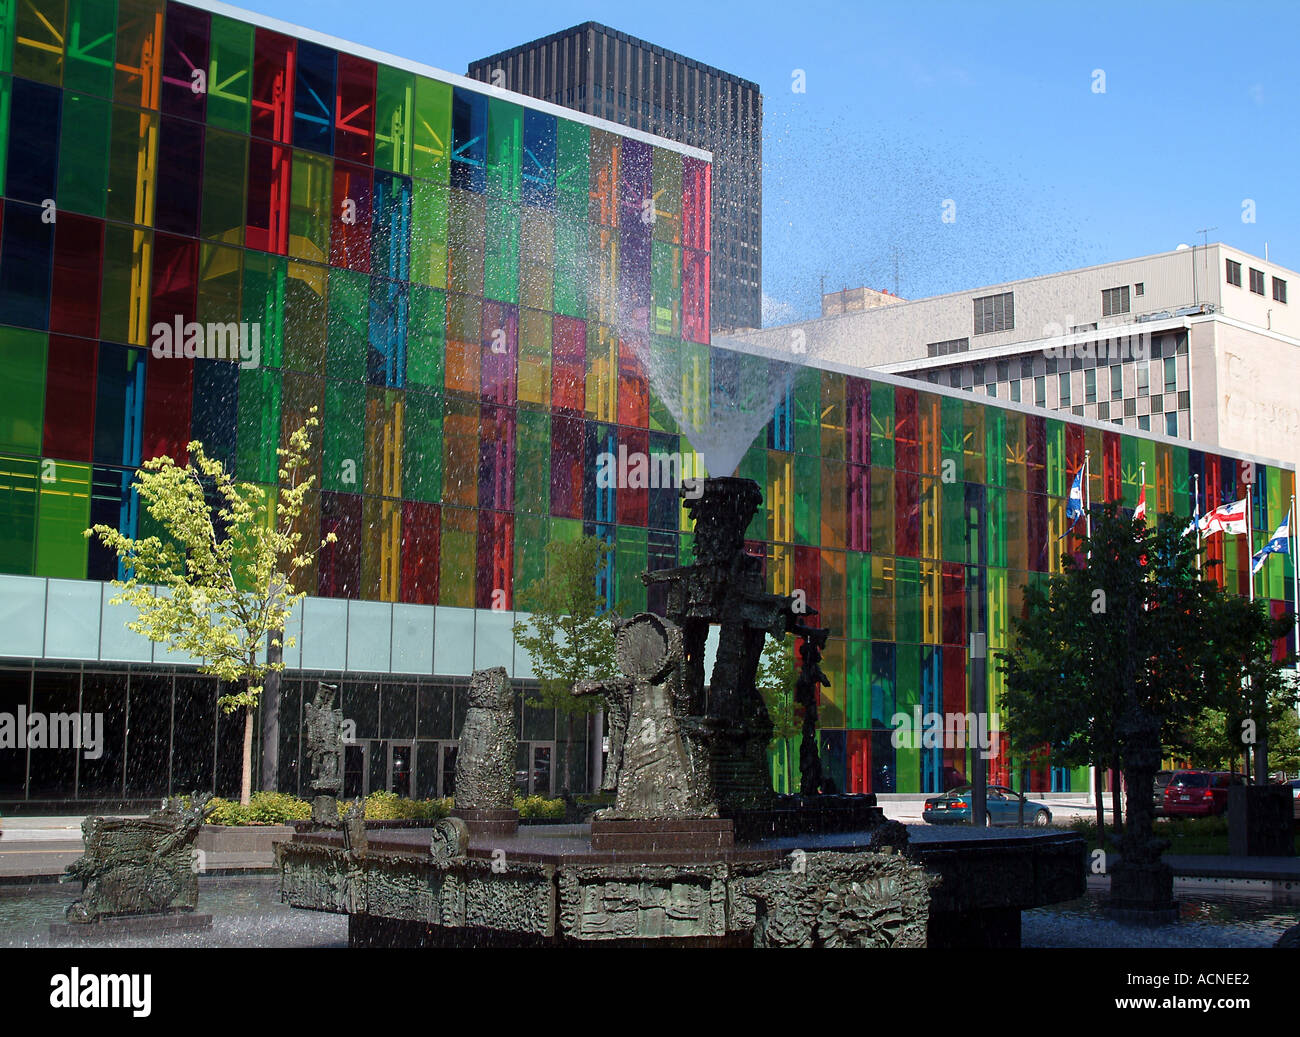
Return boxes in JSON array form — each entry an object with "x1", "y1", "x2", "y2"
[{"x1": 0, "y1": 0, "x2": 1295, "y2": 793}]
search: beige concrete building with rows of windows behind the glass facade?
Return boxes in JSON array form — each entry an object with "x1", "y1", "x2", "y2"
[{"x1": 736, "y1": 243, "x2": 1300, "y2": 475}]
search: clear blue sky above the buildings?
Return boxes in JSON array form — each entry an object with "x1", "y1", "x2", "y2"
[{"x1": 243, "y1": 0, "x2": 1300, "y2": 320}]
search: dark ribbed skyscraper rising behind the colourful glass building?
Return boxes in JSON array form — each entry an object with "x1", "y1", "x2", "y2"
[{"x1": 469, "y1": 22, "x2": 763, "y2": 330}]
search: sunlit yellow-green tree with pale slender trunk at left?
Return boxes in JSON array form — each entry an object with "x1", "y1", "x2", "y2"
[{"x1": 86, "y1": 408, "x2": 334, "y2": 806}]
